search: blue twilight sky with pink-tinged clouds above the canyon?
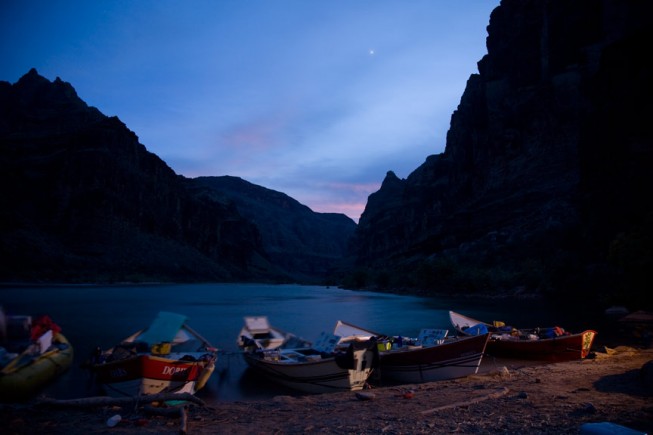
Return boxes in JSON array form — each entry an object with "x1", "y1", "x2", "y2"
[{"x1": 0, "y1": 0, "x2": 499, "y2": 221}]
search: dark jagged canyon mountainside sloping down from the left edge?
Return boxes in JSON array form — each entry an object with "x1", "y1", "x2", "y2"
[{"x1": 0, "y1": 70, "x2": 353, "y2": 282}]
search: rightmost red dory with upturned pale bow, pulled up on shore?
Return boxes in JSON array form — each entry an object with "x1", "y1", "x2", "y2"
[{"x1": 449, "y1": 311, "x2": 596, "y2": 362}]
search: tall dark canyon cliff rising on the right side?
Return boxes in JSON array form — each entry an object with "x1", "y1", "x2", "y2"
[{"x1": 349, "y1": 0, "x2": 653, "y2": 303}]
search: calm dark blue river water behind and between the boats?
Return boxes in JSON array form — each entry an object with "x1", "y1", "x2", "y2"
[{"x1": 0, "y1": 284, "x2": 591, "y2": 402}]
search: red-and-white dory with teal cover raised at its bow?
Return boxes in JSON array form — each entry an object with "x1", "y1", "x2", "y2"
[{"x1": 90, "y1": 311, "x2": 217, "y2": 397}]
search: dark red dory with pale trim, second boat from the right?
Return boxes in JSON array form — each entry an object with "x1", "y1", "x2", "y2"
[{"x1": 334, "y1": 320, "x2": 489, "y2": 384}]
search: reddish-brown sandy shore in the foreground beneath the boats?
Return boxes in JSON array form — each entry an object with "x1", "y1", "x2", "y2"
[{"x1": 0, "y1": 346, "x2": 653, "y2": 434}]
